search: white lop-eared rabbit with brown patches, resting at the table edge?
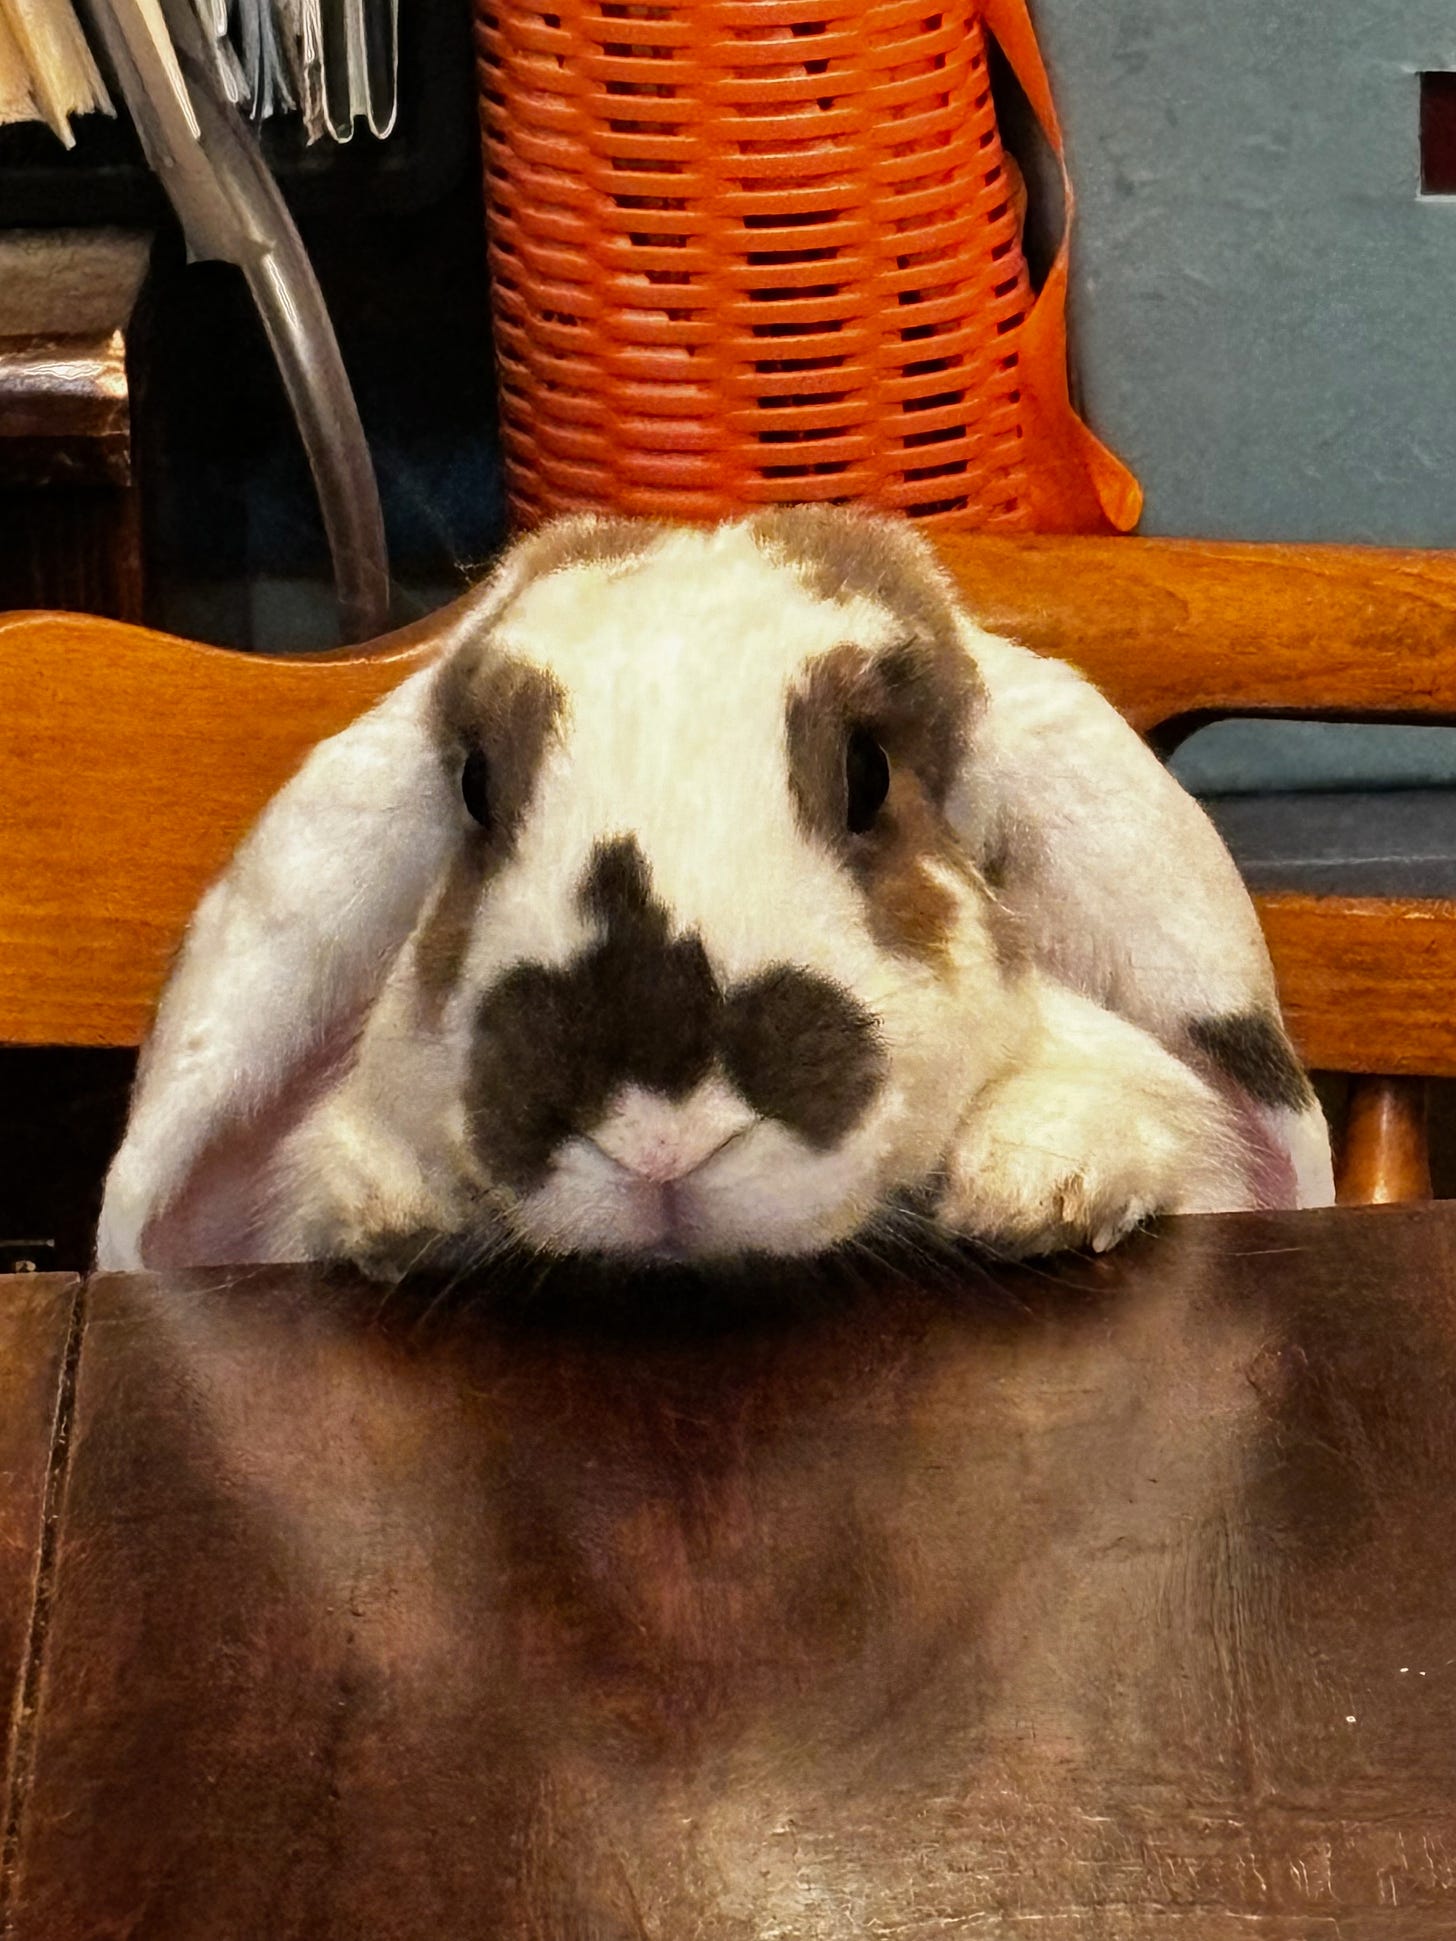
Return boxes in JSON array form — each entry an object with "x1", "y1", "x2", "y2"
[{"x1": 97, "y1": 507, "x2": 1332, "y2": 1281}]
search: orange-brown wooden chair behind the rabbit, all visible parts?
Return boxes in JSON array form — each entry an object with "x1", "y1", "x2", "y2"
[{"x1": 0, "y1": 538, "x2": 1456, "y2": 1201}]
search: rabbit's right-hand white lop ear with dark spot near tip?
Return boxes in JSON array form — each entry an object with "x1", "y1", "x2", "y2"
[{"x1": 951, "y1": 619, "x2": 1334, "y2": 1205}]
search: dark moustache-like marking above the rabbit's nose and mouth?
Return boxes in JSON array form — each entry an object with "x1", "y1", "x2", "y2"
[{"x1": 466, "y1": 837, "x2": 885, "y2": 1192}]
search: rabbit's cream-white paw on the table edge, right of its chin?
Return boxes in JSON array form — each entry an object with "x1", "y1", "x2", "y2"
[{"x1": 938, "y1": 984, "x2": 1248, "y2": 1256}]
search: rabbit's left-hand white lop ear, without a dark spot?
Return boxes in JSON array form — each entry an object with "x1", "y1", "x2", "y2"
[{"x1": 97, "y1": 668, "x2": 458, "y2": 1269}]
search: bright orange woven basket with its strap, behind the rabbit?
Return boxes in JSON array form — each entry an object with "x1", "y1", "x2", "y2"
[{"x1": 476, "y1": 0, "x2": 1138, "y2": 530}]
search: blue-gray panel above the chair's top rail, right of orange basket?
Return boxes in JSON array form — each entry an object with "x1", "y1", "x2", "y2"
[{"x1": 1035, "y1": 0, "x2": 1456, "y2": 545}]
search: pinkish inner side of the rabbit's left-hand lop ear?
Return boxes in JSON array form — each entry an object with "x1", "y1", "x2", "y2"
[{"x1": 142, "y1": 1011, "x2": 363, "y2": 1267}]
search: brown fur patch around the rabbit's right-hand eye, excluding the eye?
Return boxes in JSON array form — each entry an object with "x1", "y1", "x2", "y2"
[{"x1": 784, "y1": 639, "x2": 980, "y2": 961}]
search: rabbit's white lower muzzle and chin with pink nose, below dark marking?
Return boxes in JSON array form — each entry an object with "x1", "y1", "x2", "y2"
[{"x1": 505, "y1": 1124, "x2": 900, "y2": 1262}]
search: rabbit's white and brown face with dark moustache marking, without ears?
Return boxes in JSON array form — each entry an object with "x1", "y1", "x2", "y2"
[{"x1": 392, "y1": 514, "x2": 1017, "y2": 1256}]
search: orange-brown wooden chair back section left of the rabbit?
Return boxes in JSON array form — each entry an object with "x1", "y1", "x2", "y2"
[{"x1": 0, "y1": 613, "x2": 431, "y2": 1044}]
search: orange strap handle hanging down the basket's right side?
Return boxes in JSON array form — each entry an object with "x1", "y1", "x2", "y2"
[{"x1": 980, "y1": 0, "x2": 1143, "y2": 532}]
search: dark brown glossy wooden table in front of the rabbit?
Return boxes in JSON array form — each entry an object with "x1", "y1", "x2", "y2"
[{"x1": 0, "y1": 1205, "x2": 1456, "y2": 1941}]
